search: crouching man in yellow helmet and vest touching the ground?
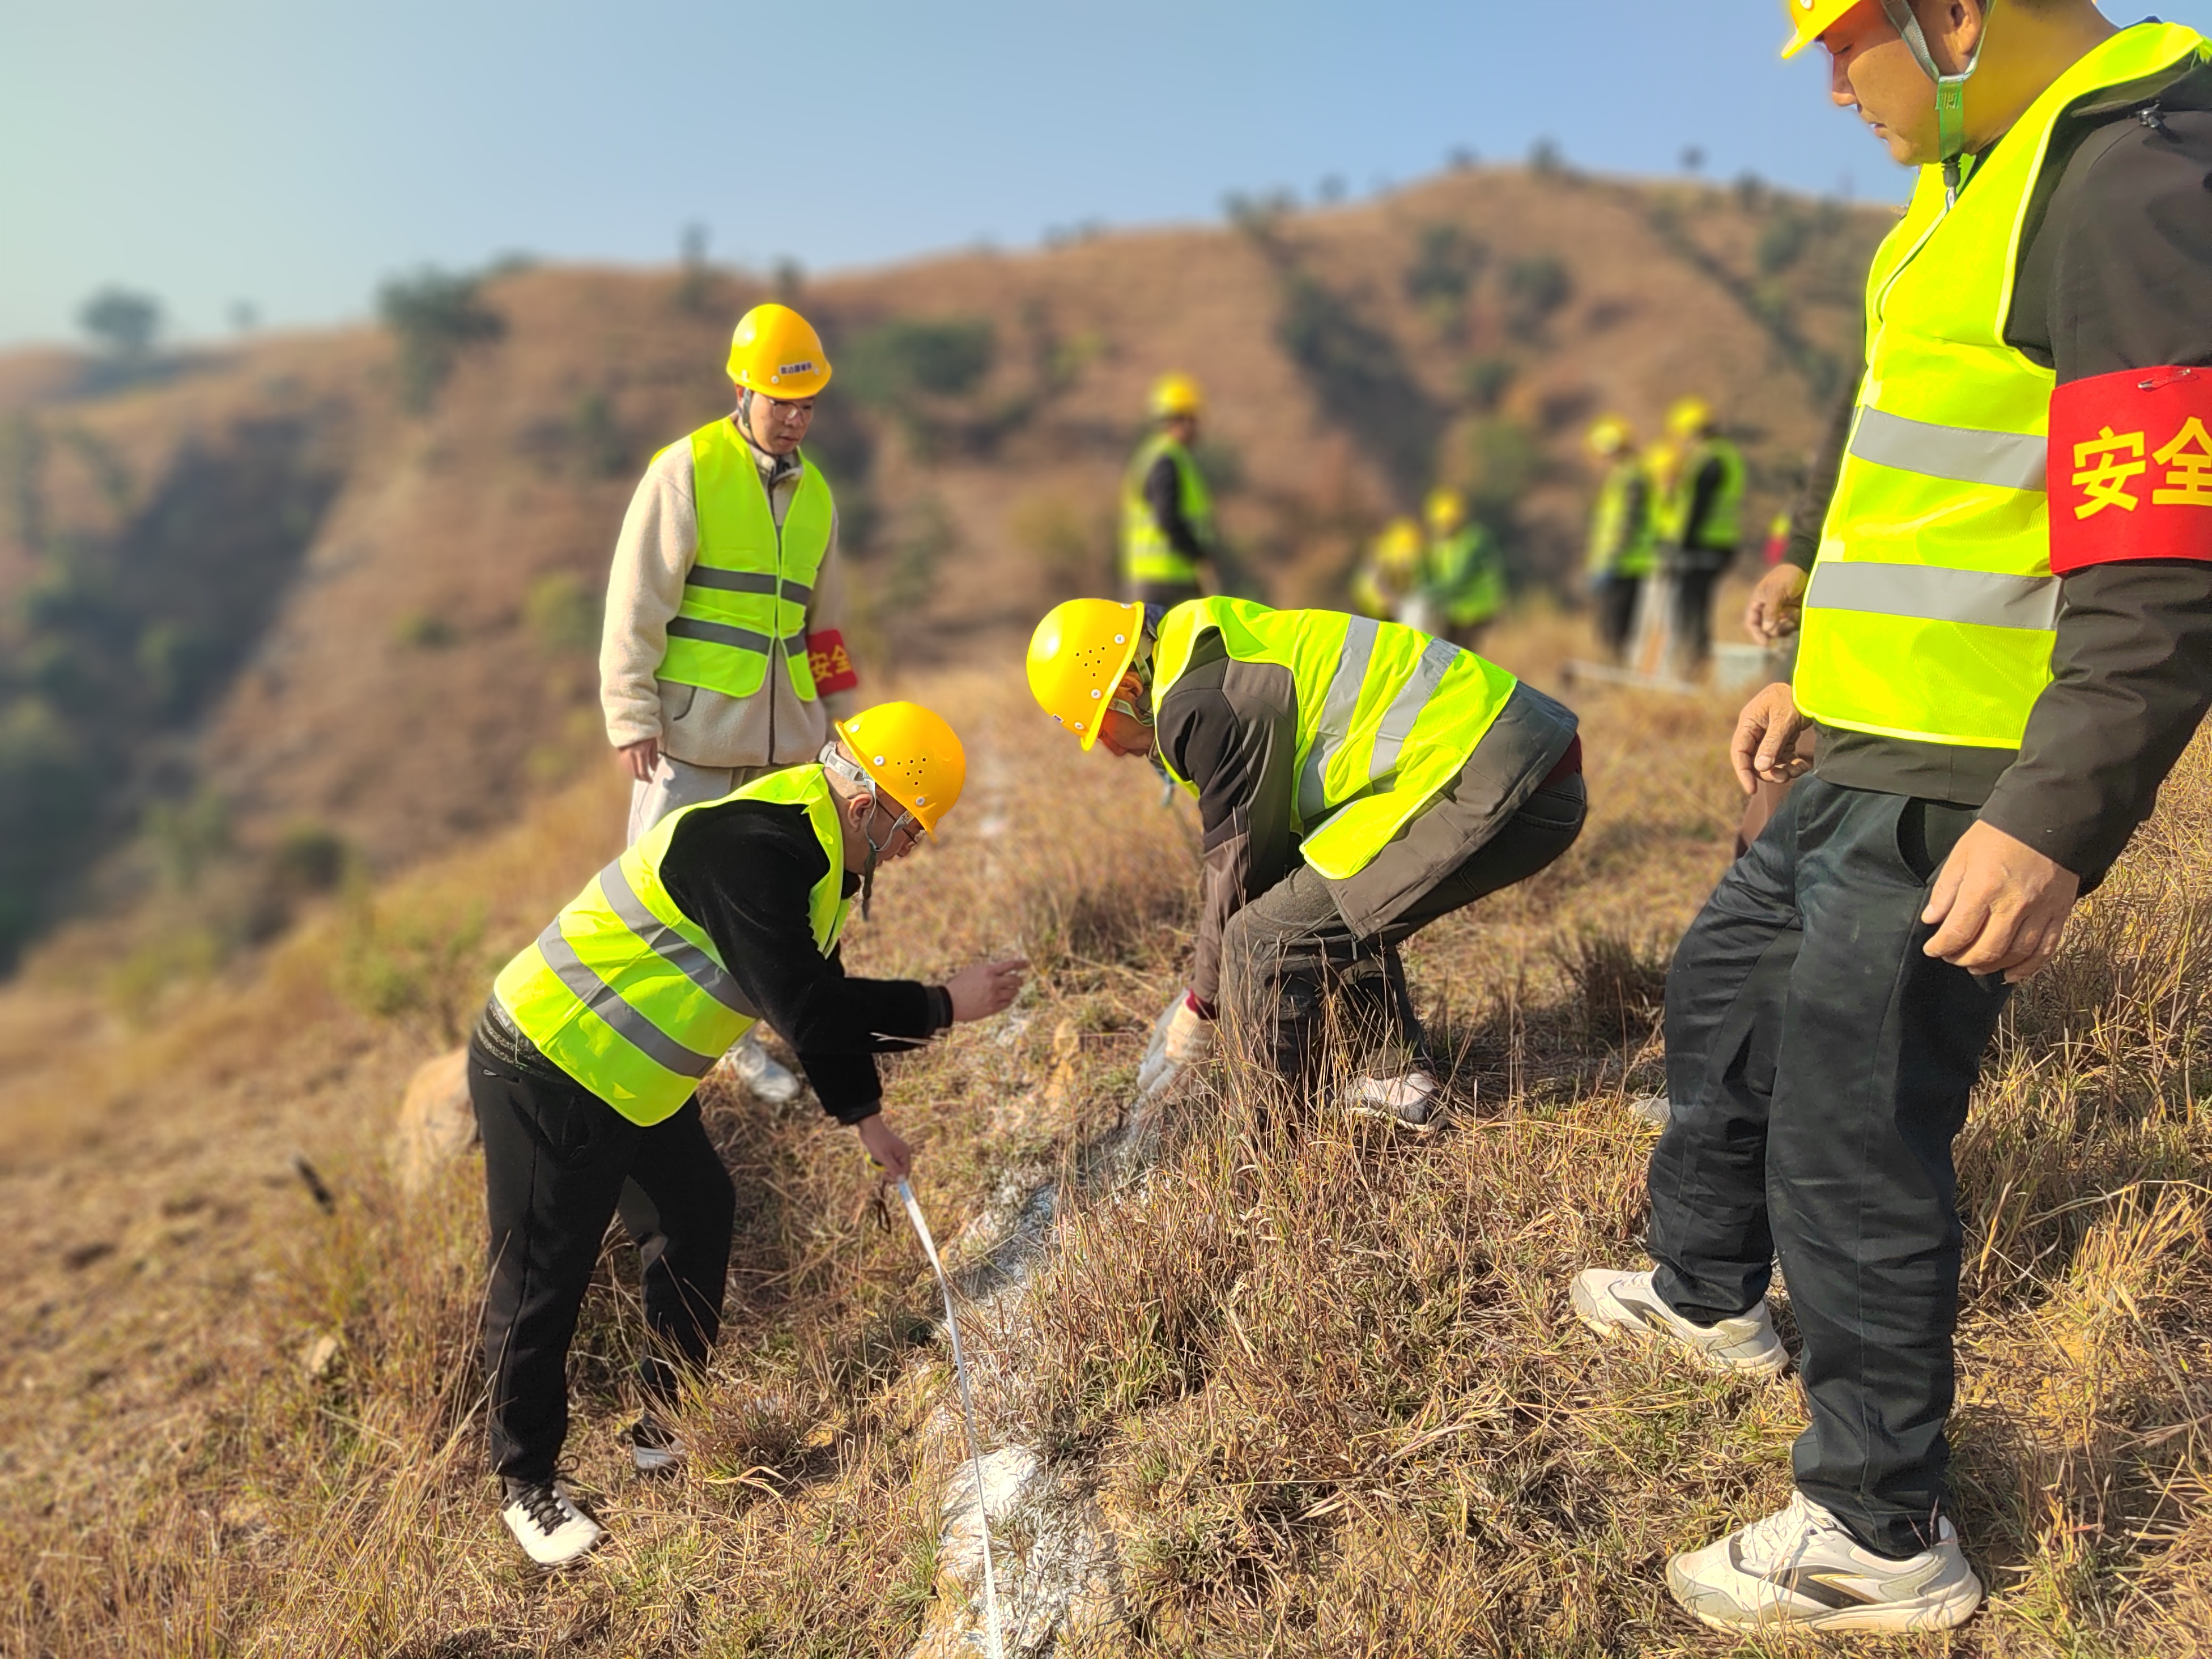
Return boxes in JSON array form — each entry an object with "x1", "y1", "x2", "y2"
[{"x1": 1028, "y1": 599, "x2": 1584, "y2": 1130}]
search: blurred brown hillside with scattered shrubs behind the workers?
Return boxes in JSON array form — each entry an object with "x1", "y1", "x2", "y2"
[{"x1": 0, "y1": 168, "x2": 1885, "y2": 980}]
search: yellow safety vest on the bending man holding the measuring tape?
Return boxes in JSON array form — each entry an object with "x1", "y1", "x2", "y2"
[{"x1": 491, "y1": 765, "x2": 852, "y2": 1124}]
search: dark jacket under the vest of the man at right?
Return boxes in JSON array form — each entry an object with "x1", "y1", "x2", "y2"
[{"x1": 1789, "y1": 52, "x2": 2212, "y2": 880}]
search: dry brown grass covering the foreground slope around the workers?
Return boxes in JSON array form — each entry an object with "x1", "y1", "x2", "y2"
[{"x1": 0, "y1": 617, "x2": 2212, "y2": 1659}]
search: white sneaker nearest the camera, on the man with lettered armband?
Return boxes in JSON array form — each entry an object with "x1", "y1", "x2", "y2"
[{"x1": 1666, "y1": 1493, "x2": 1982, "y2": 1630}]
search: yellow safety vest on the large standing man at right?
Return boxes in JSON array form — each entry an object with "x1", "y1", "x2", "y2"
[{"x1": 1794, "y1": 24, "x2": 2207, "y2": 748}]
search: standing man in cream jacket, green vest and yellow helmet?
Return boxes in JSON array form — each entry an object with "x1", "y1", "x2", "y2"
[{"x1": 599, "y1": 305, "x2": 858, "y2": 1101}]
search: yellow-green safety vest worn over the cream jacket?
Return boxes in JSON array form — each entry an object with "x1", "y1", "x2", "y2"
[{"x1": 659, "y1": 420, "x2": 834, "y2": 703}]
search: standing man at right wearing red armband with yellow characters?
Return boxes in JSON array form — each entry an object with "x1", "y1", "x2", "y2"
[{"x1": 1573, "y1": 0, "x2": 2212, "y2": 1630}]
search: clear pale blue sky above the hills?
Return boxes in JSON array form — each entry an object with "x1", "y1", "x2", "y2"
[{"x1": 0, "y1": 0, "x2": 2212, "y2": 343}]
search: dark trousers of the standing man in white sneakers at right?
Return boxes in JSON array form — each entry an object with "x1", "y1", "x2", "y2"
[{"x1": 1650, "y1": 776, "x2": 2006, "y2": 1557}]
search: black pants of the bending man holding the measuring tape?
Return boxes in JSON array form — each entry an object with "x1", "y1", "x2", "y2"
[{"x1": 469, "y1": 1042, "x2": 737, "y2": 1482}]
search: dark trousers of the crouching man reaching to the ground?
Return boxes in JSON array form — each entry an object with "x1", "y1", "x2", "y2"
[{"x1": 1221, "y1": 772, "x2": 1588, "y2": 1086}]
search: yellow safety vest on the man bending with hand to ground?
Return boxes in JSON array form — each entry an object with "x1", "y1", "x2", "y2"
[{"x1": 1152, "y1": 597, "x2": 1520, "y2": 880}]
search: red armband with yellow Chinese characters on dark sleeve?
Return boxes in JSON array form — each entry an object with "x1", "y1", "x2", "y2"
[{"x1": 2048, "y1": 367, "x2": 2212, "y2": 575}]
